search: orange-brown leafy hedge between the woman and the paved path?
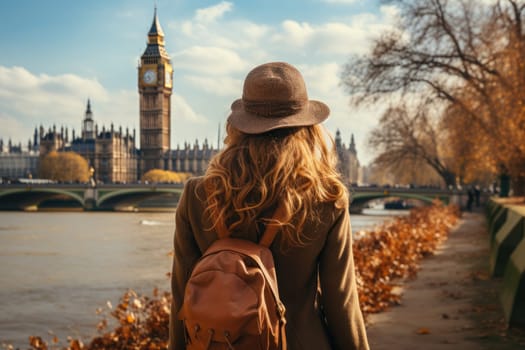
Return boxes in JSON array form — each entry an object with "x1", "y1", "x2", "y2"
[{"x1": 353, "y1": 201, "x2": 459, "y2": 315}]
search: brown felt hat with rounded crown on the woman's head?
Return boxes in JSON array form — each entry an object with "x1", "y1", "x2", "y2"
[{"x1": 228, "y1": 62, "x2": 330, "y2": 134}]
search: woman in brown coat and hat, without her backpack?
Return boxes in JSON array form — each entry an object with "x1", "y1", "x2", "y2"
[{"x1": 169, "y1": 62, "x2": 369, "y2": 350}]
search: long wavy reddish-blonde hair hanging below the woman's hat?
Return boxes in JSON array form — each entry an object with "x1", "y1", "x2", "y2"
[{"x1": 202, "y1": 123, "x2": 348, "y2": 246}]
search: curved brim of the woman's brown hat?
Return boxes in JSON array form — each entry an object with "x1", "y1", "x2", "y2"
[{"x1": 228, "y1": 99, "x2": 330, "y2": 134}]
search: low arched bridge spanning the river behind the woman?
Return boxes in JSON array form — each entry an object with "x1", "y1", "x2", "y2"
[{"x1": 0, "y1": 184, "x2": 466, "y2": 212}]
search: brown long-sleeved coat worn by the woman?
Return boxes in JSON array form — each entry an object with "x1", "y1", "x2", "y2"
[{"x1": 170, "y1": 178, "x2": 369, "y2": 350}]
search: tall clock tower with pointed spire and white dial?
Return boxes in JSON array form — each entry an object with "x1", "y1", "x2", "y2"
[{"x1": 138, "y1": 8, "x2": 173, "y2": 176}]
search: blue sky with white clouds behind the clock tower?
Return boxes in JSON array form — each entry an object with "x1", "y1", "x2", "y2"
[{"x1": 0, "y1": 0, "x2": 396, "y2": 163}]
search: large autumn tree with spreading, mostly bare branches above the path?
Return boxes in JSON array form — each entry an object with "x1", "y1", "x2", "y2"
[{"x1": 342, "y1": 0, "x2": 525, "y2": 195}]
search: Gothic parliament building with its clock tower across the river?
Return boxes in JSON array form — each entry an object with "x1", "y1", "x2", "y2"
[{"x1": 0, "y1": 9, "x2": 359, "y2": 183}]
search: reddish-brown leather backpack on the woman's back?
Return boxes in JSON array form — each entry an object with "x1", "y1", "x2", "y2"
[{"x1": 178, "y1": 209, "x2": 286, "y2": 350}]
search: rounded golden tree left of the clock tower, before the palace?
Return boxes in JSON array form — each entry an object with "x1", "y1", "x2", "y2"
[{"x1": 39, "y1": 151, "x2": 89, "y2": 183}]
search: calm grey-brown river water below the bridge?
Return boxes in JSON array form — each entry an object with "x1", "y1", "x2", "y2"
[{"x1": 0, "y1": 210, "x2": 399, "y2": 349}]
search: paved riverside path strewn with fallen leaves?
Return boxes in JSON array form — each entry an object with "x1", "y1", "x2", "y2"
[{"x1": 368, "y1": 213, "x2": 525, "y2": 350}]
